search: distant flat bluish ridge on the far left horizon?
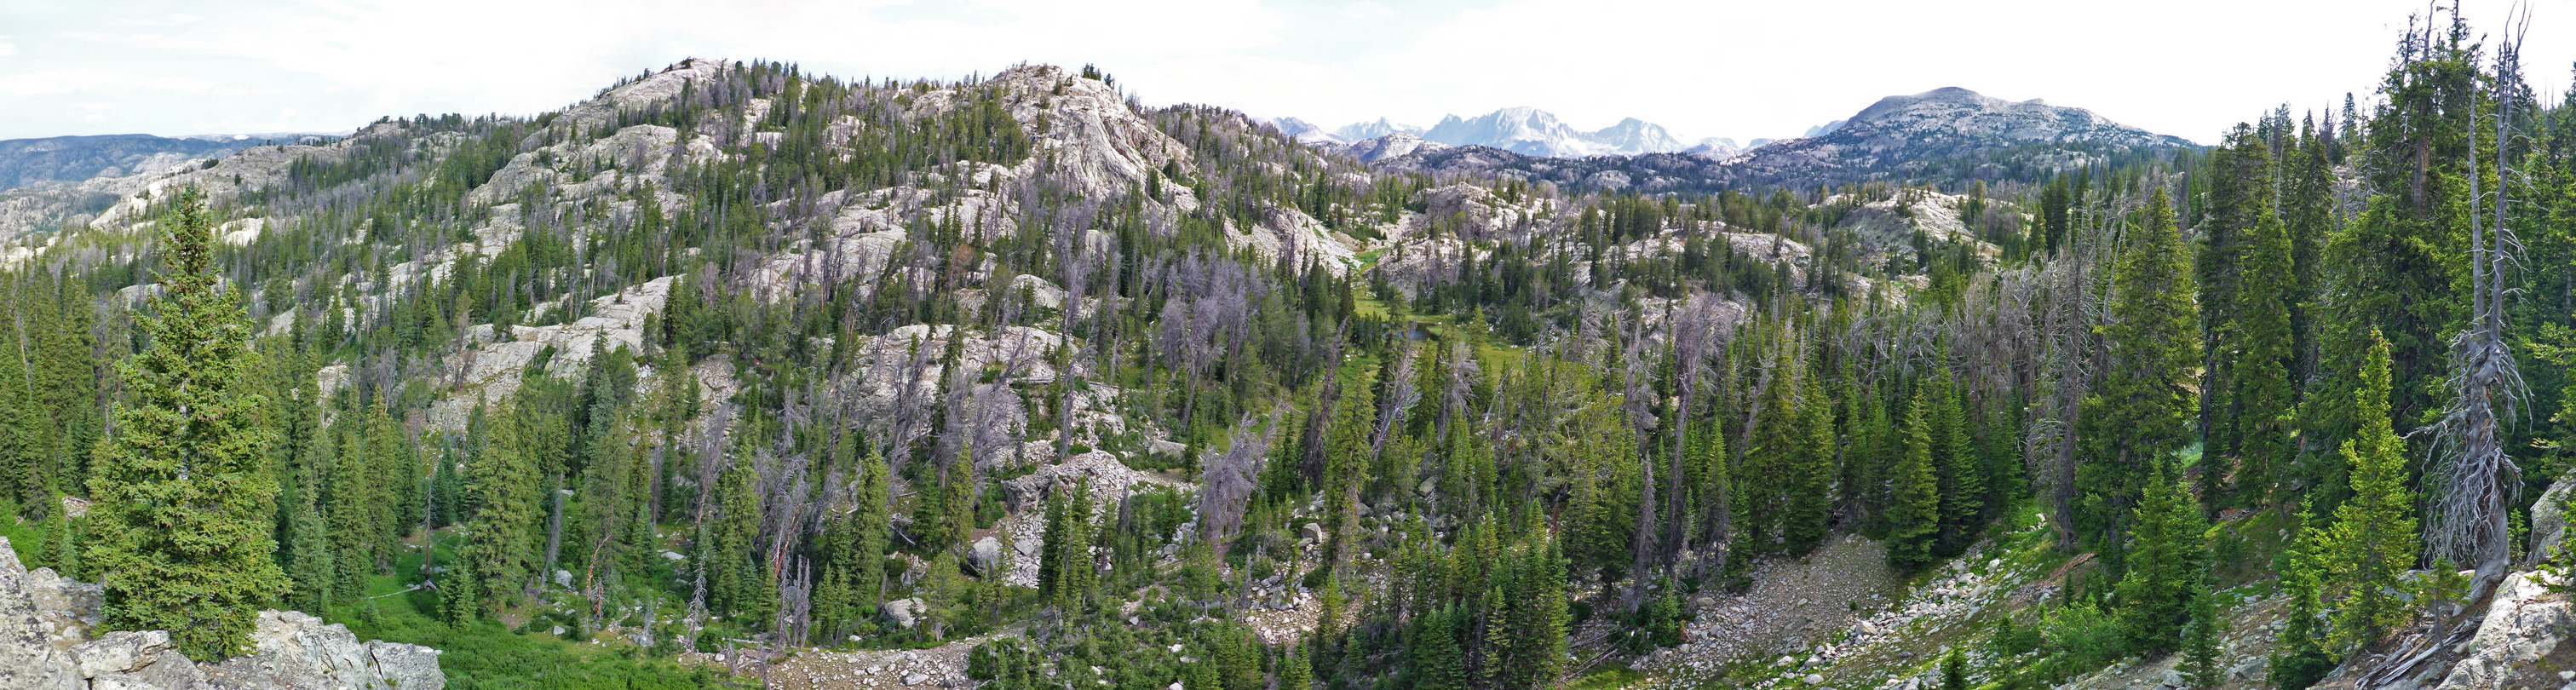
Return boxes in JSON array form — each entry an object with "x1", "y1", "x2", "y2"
[{"x1": 0, "y1": 134, "x2": 337, "y2": 191}]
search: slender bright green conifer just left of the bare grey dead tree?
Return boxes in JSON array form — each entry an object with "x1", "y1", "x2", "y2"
[{"x1": 2324, "y1": 332, "x2": 2419, "y2": 649}]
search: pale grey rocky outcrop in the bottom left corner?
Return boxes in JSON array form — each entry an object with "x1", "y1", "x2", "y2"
[{"x1": 0, "y1": 538, "x2": 448, "y2": 690}]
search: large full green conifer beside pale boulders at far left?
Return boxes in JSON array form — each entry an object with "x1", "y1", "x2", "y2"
[{"x1": 88, "y1": 188, "x2": 291, "y2": 659}]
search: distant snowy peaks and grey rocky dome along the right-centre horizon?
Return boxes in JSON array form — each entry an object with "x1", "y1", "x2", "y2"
[{"x1": 1298, "y1": 88, "x2": 2194, "y2": 193}]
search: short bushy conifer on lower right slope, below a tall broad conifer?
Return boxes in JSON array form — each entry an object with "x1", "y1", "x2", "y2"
[{"x1": 2118, "y1": 461, "x2": 2211, "y2": 654}]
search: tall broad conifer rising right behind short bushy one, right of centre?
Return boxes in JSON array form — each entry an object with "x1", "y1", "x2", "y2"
[{"x1": 2079, "y1": 188, "x2": 2199, "y2": 531}]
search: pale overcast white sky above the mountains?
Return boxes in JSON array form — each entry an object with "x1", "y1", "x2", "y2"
[{"x1": 0, "y1": 0, "x2": 2576, "y2": 141}]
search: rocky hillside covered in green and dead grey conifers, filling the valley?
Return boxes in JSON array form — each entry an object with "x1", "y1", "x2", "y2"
[{"x1": 0, "y1": 6, "x2": 2576, "y2": 690}]
